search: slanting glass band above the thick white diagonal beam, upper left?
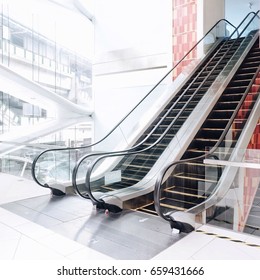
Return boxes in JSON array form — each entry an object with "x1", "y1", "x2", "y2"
[{"x1": 0, "y1": 11, "x2": 92, "y2": 104}]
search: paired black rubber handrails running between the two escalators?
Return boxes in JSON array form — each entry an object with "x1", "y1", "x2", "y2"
[{"x1": 72, "y1": 12, "x2": 255, "y2": 204}]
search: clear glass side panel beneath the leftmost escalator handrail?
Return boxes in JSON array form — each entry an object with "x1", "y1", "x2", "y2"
[{"x1": 32, "y1": 20, "x2": 235, "y2": 192}]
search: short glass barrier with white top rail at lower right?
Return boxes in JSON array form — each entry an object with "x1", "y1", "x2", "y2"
[{"x1": 204, "y1": 148, "x2": 260, "y2": 235}]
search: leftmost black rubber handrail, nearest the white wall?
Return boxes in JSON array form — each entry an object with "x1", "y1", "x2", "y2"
[{"x1": 31, "y1": 19, "x2": 238, "y2": 187}]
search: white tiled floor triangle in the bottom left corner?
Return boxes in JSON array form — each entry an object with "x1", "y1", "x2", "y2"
[{"x1": 0, "y1": 208, "x2": 114, "y2": 260}]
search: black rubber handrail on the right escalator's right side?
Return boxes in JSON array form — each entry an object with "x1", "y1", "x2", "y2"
[{"x1": 154, "y1": 50, "x2": 260, "y2": 222}]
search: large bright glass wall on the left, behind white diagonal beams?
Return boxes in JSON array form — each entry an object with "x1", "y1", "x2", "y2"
[{"x1": 0, "y1": 0, "x2": 93, "y2": 182}]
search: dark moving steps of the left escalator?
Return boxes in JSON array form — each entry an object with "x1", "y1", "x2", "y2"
[{"x1": 86, "y1": 39, "x2": 242, "y2": 191}]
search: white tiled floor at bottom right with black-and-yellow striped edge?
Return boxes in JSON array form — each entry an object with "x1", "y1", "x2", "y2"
[{"x1": 152, "y1": 225, "x2": 260, "y2": 260}]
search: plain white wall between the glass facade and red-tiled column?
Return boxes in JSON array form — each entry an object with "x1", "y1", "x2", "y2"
[{"x1": 93, "y1": 0, "x2": 172, "y2": 140}]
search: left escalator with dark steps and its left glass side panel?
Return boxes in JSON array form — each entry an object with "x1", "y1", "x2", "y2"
[{"x1": 32, "y1": 19, "x2": 237, "y2": 197}]
